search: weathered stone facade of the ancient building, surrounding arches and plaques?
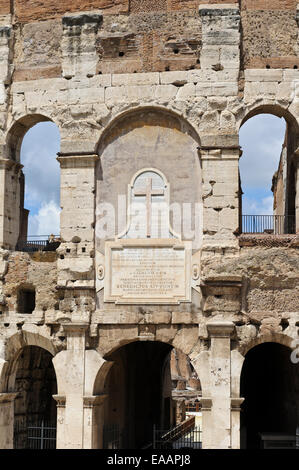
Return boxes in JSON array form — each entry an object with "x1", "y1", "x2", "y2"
[{"x1": 0, "y1": 0, "x2": 299, "y2": 448}]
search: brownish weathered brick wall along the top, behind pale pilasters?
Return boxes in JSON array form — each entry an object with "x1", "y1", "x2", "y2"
[{"x1": 0, "y1": 0, "x2": 298, "y2": 80}]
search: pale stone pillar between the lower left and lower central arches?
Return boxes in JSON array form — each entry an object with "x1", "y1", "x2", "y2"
[{"x1": 53, "y1": 322, "x2": 112, "y2": 449}]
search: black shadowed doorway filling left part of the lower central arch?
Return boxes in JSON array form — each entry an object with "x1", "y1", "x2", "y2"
[{"x1": 104, "y1": 341, "x2": 172, "y2": 449}]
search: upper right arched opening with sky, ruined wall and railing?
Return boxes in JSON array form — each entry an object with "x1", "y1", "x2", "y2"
[{"x1": 239, "y1": 106, "x2": 298, "y2": 235}]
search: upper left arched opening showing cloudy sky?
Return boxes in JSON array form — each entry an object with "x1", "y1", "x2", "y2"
[{"x1": 8, "y1": 115, "x2": 60, "y2": 251}]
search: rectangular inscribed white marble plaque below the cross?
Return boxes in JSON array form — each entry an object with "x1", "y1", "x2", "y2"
[{"x1": 104, "y1": 239, "x2": 191, "y2": 304}]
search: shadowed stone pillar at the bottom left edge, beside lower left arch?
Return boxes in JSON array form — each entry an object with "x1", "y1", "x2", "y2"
[{"x1": 0, "y1": 393, "x2": 18, "y2": 449}]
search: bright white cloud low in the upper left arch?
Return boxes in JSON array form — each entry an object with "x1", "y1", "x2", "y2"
[{"x1": 28, "y1": 201, "x2": 60, "y2": 235}]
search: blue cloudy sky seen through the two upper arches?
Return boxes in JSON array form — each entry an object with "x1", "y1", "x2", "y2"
[{"x1": 21, "y1": 114, "x2": 286, "y2": 235}]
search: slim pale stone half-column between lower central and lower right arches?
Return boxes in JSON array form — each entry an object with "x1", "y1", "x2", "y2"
[{"x1": 205, "y1": 321, "x2": 234, "y2": 449}]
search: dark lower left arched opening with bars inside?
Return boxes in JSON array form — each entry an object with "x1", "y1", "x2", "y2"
[{"x1": 14, "y1": 346, "x2": 57, "y2": 449}]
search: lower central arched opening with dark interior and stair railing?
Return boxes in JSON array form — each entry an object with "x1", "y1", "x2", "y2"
[{"x1": 96, "y1": 341, "x2": 201, "y2": 449}]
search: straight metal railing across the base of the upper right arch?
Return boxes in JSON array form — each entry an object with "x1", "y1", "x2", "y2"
[{"x1": 242, "y1": 215, "x2": 295, "y2": 235}]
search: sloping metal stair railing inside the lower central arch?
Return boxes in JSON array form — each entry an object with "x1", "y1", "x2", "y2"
[{"x1": 153, "y1": 416, "x2": 202, "y2": 449}]
